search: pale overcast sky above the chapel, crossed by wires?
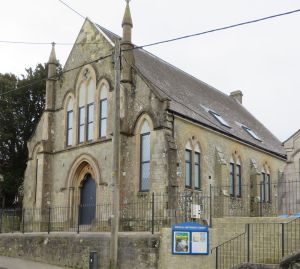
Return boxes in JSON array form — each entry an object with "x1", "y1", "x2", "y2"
[{"x1": 0, "y1": 0, "x2": 300, "y2": 141}]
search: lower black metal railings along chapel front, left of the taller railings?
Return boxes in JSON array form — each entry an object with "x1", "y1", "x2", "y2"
[{"x1": 0, "y1": 192, "x2": 211, "y2": 233}]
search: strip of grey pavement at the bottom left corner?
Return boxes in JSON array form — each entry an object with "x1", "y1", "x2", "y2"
[{"x1": 0, "y1": 256, "x2": 67, "y2": 269}]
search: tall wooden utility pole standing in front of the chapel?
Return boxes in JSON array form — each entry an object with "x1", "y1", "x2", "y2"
[{"x1": 110, "y1": 40, "x2": 121, "y2": 269}]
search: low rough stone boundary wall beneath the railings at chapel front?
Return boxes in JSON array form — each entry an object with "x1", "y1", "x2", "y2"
[{"x1": 0, "y1": 232, "x2": 160, "y2": 269}]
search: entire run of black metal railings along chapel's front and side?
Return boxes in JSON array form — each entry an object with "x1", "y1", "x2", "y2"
[{"x1": 0, "y1": 180, "x2": 300, "y2": 232}]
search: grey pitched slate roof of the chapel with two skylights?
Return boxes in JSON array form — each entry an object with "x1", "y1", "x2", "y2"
[{"x1": 96, "y1": 25, "x2": 285, "y2": 157}]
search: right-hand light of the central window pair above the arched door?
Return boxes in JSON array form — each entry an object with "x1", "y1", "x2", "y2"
[{"x1": 86, "y1": 80, "x2": 95, "y2": 141}]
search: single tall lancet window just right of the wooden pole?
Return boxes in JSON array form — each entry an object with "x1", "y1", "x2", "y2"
[{"x1": 140, "y1": 120, "x2": 151, "y2": 191}]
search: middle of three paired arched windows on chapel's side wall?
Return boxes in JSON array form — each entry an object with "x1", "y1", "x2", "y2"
[{"x1": 229, "y1": 155, "x2": 242, "y2": 197}]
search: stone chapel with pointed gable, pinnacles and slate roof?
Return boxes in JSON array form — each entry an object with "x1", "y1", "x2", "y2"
[{"x1": 23, "y1": 4, "x2": 286, "y2": 222}]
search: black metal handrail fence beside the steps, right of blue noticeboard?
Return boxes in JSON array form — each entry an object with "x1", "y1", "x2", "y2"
[{"x1": 212, "y1": 218, "x2": 300, "y2": 269}]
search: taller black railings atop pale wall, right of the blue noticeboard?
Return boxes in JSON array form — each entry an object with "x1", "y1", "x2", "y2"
[{"x1": 211, "y1": 180, "x2": 300, "y2": 217}]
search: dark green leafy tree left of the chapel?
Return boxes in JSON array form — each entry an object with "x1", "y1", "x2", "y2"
[{"x1": 0, "y1": 64, "x2": 51, "y2": 206}]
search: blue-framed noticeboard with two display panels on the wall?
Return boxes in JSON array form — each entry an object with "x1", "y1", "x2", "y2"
[{"x1": 172, "y1": 222, "x2": 209, "y2": 255}]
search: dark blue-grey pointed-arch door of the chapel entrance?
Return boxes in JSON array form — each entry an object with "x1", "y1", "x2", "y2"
[{"x1": 79, "y1": 174, "x2": 96, "y2": 225}]
